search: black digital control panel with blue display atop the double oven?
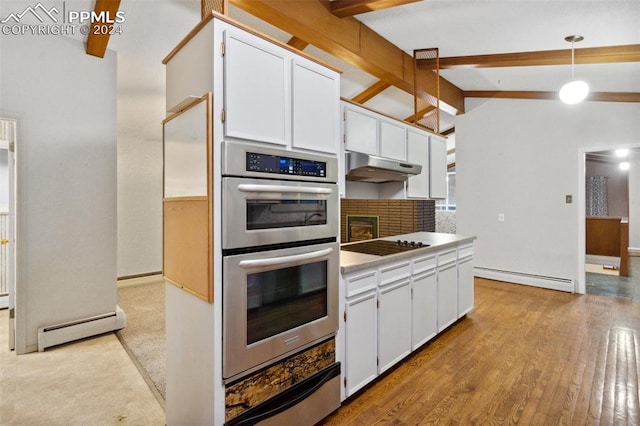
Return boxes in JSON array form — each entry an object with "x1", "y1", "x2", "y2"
[{"x1": 246, "y1": 152, "x2": 327, "y2": 178}]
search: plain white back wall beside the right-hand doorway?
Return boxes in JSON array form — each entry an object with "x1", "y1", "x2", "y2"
[{"x1": 456, "y1": 99, "x2": 640, "y2": 290}]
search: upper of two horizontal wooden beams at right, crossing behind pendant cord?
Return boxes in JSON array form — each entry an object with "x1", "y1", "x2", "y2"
[{"x1": 418, "y1": 44, "x2": 640, "y2": 69}]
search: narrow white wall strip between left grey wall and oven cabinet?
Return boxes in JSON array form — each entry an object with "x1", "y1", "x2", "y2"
[{"x1": 114, "y1": 0, "x2": 200, "y2": 277}]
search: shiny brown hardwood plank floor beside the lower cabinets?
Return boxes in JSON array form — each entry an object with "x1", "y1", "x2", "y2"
[{"x1": 323, "y1": 278, "x2": 640, "y2": 425}]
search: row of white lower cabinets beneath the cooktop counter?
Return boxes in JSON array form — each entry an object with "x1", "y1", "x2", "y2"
[{"x1": 342, "y1": 244, "x2": 474, "y2": 398}]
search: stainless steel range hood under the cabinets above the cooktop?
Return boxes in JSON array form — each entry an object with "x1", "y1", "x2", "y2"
[{"x1": 346, "y1": 152, "x2": 422, "y2": 183}]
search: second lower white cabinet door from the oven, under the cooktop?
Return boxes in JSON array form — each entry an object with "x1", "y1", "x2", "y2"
[{"x1": 378, "y1": 278, "x2": 411, "y2": 373}]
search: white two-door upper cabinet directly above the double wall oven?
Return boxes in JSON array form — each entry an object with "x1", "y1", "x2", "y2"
[{"x1": 165, "y1": 19, "x2": 341, "y2": 154}]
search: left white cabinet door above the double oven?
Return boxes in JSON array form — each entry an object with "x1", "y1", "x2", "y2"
[{"x1": 224, "y1": 29, "x2": 291, "y2": 145}]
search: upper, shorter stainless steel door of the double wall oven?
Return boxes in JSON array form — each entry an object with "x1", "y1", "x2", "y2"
[{"x1": 222, "y1": 177, "x2": 338, "y2": 249}]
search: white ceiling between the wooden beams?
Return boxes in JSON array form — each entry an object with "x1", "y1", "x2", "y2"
[{"x1": 222, "y1": 0, "x2": 640, "y2": 130}]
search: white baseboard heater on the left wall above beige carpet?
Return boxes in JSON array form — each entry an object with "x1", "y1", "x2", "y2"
[{"x1": 38, "y1": 306, "x2": 127, "y2": 352}]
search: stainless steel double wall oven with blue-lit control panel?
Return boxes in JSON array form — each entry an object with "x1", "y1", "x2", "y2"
[{"x1": 222, "y1": 142, "x2": 340, "y2": 380}]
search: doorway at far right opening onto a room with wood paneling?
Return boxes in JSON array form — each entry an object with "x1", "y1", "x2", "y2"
[{"x1": 578, "y1": 145, "x2": 640, "y2": 301}]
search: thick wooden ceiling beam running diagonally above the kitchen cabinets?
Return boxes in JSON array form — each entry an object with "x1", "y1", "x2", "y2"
[{"x1": 230, "y1": 0, "x2": 464, "y2": 115}]
